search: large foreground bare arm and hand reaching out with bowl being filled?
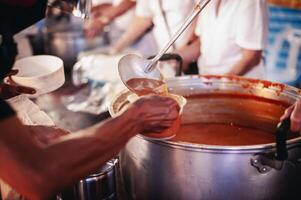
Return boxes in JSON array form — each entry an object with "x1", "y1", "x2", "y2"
[{"x1": 0, "y1": 96, "x2": 178, "y2": 200}]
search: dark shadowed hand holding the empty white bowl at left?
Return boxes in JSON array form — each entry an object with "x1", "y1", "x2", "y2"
[{"x1": 0, "y1": 70, "x2": 36, "y2": 99}]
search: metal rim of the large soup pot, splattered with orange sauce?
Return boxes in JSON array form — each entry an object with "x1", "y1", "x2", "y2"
[{"x1": 108, "y1": 75, "x2": 301, "y2": 153}]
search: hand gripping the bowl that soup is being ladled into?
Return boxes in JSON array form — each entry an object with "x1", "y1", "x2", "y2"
[{"x1": 129, "y1": 95, "x2": 180, "y2": 133}]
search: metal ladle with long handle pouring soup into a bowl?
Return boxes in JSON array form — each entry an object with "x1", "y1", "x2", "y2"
[{"x1": 118, "y1": 0, "x2": 211, "y2": 90}]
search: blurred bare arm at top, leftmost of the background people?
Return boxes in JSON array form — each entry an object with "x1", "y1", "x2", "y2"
[{"x1": 84, "y1": 0, "x2": 136, "y2": 38}]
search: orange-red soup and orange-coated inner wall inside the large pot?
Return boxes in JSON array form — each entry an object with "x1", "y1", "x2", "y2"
[{"x1": 172, "y1": 93, "x2": 298, "y2": 146}]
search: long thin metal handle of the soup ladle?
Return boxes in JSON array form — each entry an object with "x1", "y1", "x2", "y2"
[{"x1": 145, "y1": 0, "x2": 211, "y2": 73}]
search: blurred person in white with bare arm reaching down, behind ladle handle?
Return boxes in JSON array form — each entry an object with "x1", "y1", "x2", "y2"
[{"x1": 112, "y1": 0, "x2": 194, "y2": 52}]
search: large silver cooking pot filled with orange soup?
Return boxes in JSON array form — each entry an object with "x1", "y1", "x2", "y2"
[{"x1": 110, "y1": 76, "x2": 301, "y2": 200}]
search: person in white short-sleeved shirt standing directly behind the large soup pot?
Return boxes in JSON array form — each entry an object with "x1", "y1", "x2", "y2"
[{"x1": 178, "y1": 0, "x2": 267, "y2": 78}]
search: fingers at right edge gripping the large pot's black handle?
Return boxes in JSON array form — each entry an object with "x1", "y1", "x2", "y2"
[{"x1": 280, "y1": 100, "x2": 301, "y2": 132}]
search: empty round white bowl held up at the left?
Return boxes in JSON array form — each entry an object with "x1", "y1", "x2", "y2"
[{"x1": 12, "y1": 55, "x2": 65, "y2": 97}]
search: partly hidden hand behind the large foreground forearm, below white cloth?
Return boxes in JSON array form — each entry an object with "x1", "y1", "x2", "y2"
[{"x1": 27, "y1": 126, "x2": 69, "y2": 144}]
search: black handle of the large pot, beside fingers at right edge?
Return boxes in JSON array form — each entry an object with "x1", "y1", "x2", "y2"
[{"x1": 275, "y1": 117, "x2": 291, "y2": 161}]
